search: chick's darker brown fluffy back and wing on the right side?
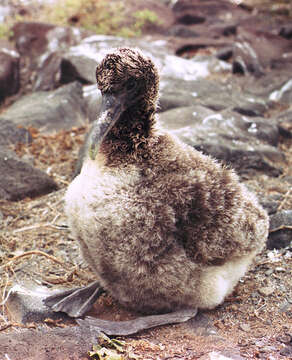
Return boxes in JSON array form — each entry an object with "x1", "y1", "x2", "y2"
[{"x1": 130, "y1": 134, "x2": 268, "y2": 264}]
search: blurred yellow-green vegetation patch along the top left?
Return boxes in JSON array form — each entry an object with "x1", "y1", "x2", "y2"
[{"x1": 0, "y1": 0, "x2": 159, "y2": 38}]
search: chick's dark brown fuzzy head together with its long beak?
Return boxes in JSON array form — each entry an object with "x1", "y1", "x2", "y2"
[{"x1": 89, "y1": 48, "x2": 159, "y2": 159}]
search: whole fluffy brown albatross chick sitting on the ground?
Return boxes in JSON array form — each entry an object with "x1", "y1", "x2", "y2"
[{"x1": 46, "y1": 48, "x2": 268, "y2": 334}]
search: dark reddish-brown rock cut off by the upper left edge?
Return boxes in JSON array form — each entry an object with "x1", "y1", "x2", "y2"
[{"x1": 0, "y1": 40, "x2": 19, "y2": 102}]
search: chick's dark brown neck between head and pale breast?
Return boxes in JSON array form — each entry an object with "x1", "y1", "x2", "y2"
[{"x1": 100, "y1": 104, "x2": 156, "y2": 166}]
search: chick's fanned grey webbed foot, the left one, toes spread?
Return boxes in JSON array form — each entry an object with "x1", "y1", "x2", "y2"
[{"x1": 43, "y1": 281, "x2": 104, "y2": 318}]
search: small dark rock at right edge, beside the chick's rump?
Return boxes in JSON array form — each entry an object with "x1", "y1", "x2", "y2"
[{"x1": 267, "y1": 210, "x2": 292, "y2": 250}]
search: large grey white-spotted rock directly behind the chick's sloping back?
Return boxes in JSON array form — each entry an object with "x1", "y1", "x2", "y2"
[{"x1": 159, "y1": 106, "x2": 283, "y2": 176}]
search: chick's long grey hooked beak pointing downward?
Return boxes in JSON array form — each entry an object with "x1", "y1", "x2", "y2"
[{"x1": 89, "y1": 94, "x2": 124, "y2": 160}]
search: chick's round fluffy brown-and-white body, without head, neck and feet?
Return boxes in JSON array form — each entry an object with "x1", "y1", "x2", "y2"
[{"x1": 65, "y1": 126, "x2": 268, "y2": 313}]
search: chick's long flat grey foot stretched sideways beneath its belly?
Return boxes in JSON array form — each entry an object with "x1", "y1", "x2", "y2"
[{"x1": 77, "y1": 309, "x2": 198, "y2": 335}]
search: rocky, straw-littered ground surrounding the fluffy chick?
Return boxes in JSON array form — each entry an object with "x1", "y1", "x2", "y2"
[{"x1": 0, "y1": 0, "x2": 292, "y2": 360}]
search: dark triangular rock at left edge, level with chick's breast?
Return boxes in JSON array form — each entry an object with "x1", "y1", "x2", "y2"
[{"x1": 0, "y1": 148, "x2": 57, "y2": 201}]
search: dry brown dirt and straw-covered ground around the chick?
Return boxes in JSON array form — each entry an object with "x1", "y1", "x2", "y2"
[{"x1": 0, "y1": 122, "x2": 292, "y2": 360}]
